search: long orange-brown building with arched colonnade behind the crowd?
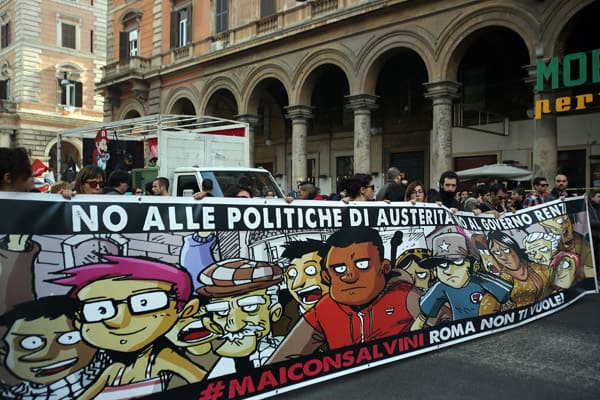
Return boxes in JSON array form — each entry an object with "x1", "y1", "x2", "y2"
[{"x1": 97, "y1": 0, "x2": 600, "y2": 193}]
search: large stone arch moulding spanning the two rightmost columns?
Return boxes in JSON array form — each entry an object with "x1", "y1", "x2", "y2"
[{"x1": 432, "y1": 5, "x2": 539, "y2": 81}]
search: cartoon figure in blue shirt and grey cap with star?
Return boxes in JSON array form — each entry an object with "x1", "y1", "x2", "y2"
[{"x1": 411, "y1": 232, "x2": 512, "y2": 330}]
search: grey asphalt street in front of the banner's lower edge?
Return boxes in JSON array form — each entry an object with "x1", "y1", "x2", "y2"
[{"x1": 276, "y1": 295, "x2": 600, "y2": 400}]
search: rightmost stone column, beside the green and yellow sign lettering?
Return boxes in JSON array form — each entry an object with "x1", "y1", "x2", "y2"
[{"x1": 525, "y1": 65, "x2": 558, "y2": 182}]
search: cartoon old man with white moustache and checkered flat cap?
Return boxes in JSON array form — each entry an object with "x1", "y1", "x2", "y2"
[{"x1": 197, "y1": 258, "x2": 283, "y2": 378}]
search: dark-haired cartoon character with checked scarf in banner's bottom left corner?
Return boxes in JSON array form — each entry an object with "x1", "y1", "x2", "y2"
[{"x1": 0, "y1": 296, "x2": 110, "y2": 400}]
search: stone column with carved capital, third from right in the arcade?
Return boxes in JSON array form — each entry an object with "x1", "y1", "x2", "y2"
[{"x1": 346, "y1": 93, "x2": 378, "y2": 174}]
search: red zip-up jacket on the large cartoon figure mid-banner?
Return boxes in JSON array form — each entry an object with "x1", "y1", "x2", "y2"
[{"x1": 304, "y1": 279, "x2": 414, "y2": 349}]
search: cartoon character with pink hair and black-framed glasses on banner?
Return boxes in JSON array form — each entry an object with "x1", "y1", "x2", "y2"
[{"x1": 53, "y1": 256, "x2": 206, "y2": 399}]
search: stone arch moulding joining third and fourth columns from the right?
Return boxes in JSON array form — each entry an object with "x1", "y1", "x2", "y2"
[{"x1": 290, "y1": 49, "x2": 356, "y2": 105}]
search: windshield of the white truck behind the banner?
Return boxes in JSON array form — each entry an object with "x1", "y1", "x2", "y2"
[{"x1": 202, "y1": 171, "x2": 284, "y2": 198}]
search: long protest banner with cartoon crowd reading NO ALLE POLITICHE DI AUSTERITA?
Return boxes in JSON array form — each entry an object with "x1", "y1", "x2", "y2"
[{"x1": 0, "y1": 193, "x2": 597, "y2": 400}]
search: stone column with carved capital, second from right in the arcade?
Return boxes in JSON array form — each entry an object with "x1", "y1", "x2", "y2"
[{"x1": 424, "y1": 81, "x2": 461, "y2": 188}]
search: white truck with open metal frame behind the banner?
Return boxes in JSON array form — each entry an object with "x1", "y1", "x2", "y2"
[{"x1": 58, "y1": 115, "x2": 284, "y2": 198}]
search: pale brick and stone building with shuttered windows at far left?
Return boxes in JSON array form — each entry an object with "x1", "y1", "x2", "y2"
[{"x1": 0, "y1": 0, "x2": 108, "y2": 172}]
